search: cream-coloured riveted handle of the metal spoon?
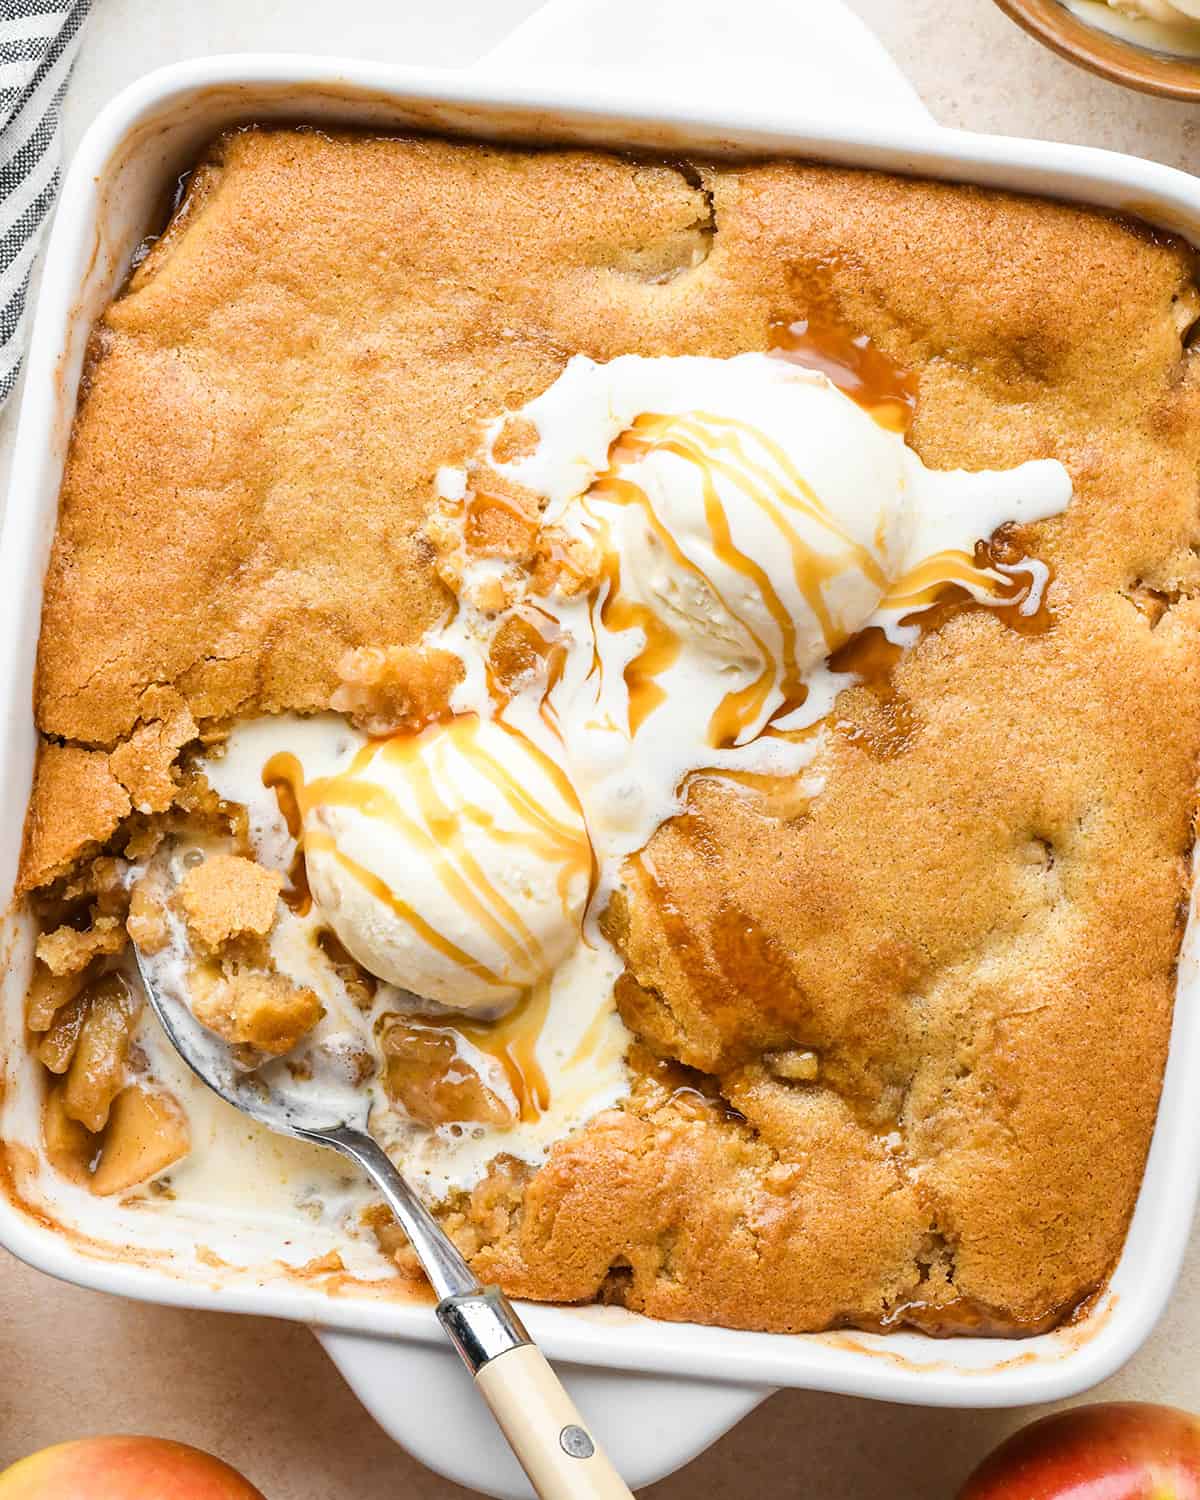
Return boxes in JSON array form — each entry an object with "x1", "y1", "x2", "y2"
[{"x1": 476, "y1": 1344, "x2": 633, "y2": 1500}]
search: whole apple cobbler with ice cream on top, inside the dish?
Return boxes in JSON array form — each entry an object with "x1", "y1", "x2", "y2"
[{"x1": 9, "y1": 129, "x2": 1200, "y2": 1334}]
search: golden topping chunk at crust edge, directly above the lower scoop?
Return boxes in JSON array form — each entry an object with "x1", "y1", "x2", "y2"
[{"x1": 330, "y1": 647, "x2": 464, "y2": 735}]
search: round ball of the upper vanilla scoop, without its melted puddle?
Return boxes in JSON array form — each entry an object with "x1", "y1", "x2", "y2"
[{"x1": 594, "y1": 367, "x2": 912, "y2": 708}]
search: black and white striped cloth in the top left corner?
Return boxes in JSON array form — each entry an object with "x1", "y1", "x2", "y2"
[{"x1": 0, "y1": 0, "x2": 92, "y2": 404}]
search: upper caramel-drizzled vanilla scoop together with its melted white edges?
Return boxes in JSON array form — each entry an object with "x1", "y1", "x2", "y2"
[{"x1": 486, "y1": 354, "x2": 1070, "y2": 744}]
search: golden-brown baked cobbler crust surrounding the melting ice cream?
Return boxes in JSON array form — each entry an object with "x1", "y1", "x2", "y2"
[{"x1": 23, "y1": 132, "x2": 1200, "y2": 1329}]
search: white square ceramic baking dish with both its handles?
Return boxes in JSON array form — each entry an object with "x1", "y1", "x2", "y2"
[{"x1": 0, "y1": 0, "x2": 1200, "y2": 1496}]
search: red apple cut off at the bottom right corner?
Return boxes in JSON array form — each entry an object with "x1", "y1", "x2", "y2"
[{"x1": 960, "y1": 1401, "x2": 1200, "y2": 1500}]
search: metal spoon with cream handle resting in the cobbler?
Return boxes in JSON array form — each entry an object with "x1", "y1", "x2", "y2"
[{"x1": 134, "y1": 947, "x2": 633, "y2": 1500}]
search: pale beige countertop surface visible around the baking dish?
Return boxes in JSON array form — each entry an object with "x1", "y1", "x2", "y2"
[{"x1": 0, "y1": 0, "x2": 1200, "y2": 1500}]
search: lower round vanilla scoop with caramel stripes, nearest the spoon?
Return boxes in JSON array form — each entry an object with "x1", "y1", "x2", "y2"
[{"x1": 305, "y1": 716, "x2": 591, "y2": 1010}]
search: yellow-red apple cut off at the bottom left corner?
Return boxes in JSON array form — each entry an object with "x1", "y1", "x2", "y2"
[{"x1": 0, "y1": 1437, "x2": 266, "y2": 1500}]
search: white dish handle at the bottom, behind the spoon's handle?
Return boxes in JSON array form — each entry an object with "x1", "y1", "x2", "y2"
[{"x1": 317, "y1": 1311, "x2": 771, "y2": 1500}]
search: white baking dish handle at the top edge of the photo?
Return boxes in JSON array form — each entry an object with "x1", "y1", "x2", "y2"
[{"x1": 473, "y1": 0, "x2": 930, "y2": 126}]
